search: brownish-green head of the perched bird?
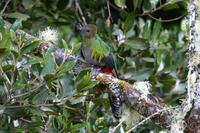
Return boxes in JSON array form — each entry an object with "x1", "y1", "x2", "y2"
[{"x1": 80, "y1": 24, "x2": 97, "y2": 38}]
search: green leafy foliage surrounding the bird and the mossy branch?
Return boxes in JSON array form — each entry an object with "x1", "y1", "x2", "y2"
[{"x1": 0, "y1": 0, "x2": 188, "y2": 133}]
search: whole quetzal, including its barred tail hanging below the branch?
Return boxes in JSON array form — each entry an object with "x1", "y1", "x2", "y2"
[{"x1": 80, "y1": 24, "x2": 121, "y2": 118}]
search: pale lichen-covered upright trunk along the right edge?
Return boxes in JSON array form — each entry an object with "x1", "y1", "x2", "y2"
[{"x1": 185, "y1": 0, "x2": 200, "y2": 133}]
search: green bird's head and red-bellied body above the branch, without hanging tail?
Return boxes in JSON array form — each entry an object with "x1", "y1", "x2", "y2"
[{"x1": 80, "y1": 24, "x2": 117, "y2": 76}]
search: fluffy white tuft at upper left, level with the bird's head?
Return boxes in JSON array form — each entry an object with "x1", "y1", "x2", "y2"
[{"x1": 38, "y1": 27, "x2": 58, "y2": 42}]
